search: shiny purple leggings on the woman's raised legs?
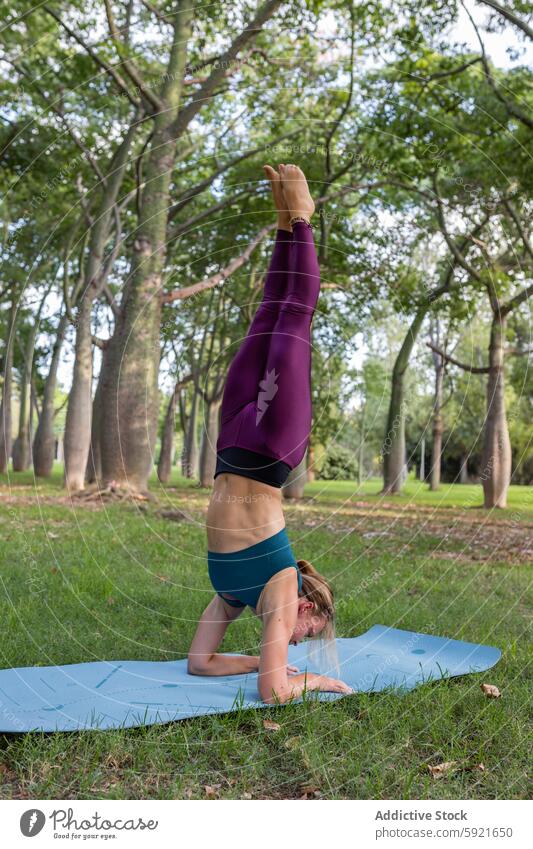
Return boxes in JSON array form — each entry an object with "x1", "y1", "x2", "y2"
[{"x1": 217, "y1": 222, "x2": 320, "y2": 468}]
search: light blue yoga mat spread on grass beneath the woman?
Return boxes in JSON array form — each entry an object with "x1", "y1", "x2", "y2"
[{"x1": 0, "y1": 625, "x2": 501, "y2": 732}]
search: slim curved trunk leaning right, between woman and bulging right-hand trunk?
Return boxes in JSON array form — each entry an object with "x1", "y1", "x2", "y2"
[{"x1": 382, "y1": 305, "x2": 428, "y2": 494}]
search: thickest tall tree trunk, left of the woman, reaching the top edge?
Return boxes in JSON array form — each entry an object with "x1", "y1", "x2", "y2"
[{"x1": 98, "y1": 6, "x2": 193, "y2": 491}]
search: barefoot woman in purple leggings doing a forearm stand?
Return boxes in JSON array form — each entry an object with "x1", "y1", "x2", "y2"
[{"x1": 188, "y1": 165, "x2": 351, "y2": 704}]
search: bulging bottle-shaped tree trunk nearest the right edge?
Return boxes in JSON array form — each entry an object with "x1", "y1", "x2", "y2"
[{"x1": 481, "y1": 314, "x2": 512, "y2": 508}]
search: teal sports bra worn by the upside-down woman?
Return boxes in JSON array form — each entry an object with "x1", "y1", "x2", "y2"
[{"x1": 207, "y1": 528, "x2": 302, "y2": 609}]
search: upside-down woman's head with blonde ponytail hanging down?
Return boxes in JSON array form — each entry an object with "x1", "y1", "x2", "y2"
[{"x1": 289, "y1": 560, "x2": 335, "y2": 645}]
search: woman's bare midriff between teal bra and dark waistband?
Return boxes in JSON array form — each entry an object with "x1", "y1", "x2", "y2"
[{"x1": 206, "y1": 473, "x2": 285, "y2": 554}]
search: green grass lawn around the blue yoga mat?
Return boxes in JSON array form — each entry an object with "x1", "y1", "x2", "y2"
[{"x1": 0, "y1": 467, "x2": 533, "y2": 799}]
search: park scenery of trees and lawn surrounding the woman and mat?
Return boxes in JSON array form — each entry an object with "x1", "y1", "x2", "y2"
[{"x1": 0, "y1": 0, "x2": 533, "y2": 798}]
